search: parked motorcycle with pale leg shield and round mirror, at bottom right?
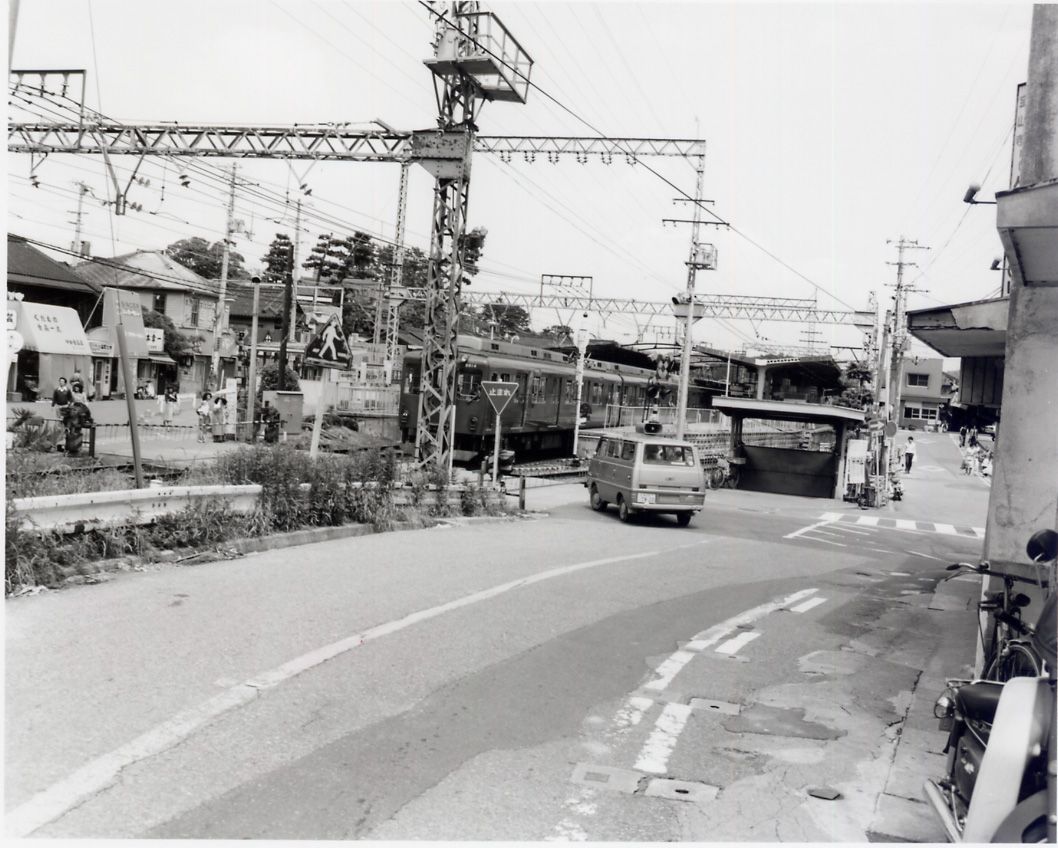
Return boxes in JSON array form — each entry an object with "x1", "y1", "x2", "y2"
[{"x1": 924, "y1": 530, "x2": 1058, "y2": 843}]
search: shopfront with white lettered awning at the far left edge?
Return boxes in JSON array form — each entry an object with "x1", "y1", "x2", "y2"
[{"x1": 7, "y1": 300, "x2": 92, "y2": 401}]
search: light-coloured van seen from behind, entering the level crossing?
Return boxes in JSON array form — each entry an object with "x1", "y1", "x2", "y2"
[{"x1": 584, "y1": 432, "x2": 706, "y2": 527}]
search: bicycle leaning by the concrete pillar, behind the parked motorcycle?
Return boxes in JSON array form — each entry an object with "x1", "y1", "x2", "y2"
[{"x1": 946, "y1": 560, "x2": 1051, "y2": 683}]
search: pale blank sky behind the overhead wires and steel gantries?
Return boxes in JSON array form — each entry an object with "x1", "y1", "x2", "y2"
[{"x1": 7, "y1": 0, "x2": 1032, "y2": 356}]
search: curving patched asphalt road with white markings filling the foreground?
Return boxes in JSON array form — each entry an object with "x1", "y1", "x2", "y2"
[{"x1": 6, "y1": 427, "x2": 986, "y2": 841}]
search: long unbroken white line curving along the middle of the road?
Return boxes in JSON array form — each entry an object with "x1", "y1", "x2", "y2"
[{"x1": 4, "y1": 551, "x2": 668, "y2": 837}]
